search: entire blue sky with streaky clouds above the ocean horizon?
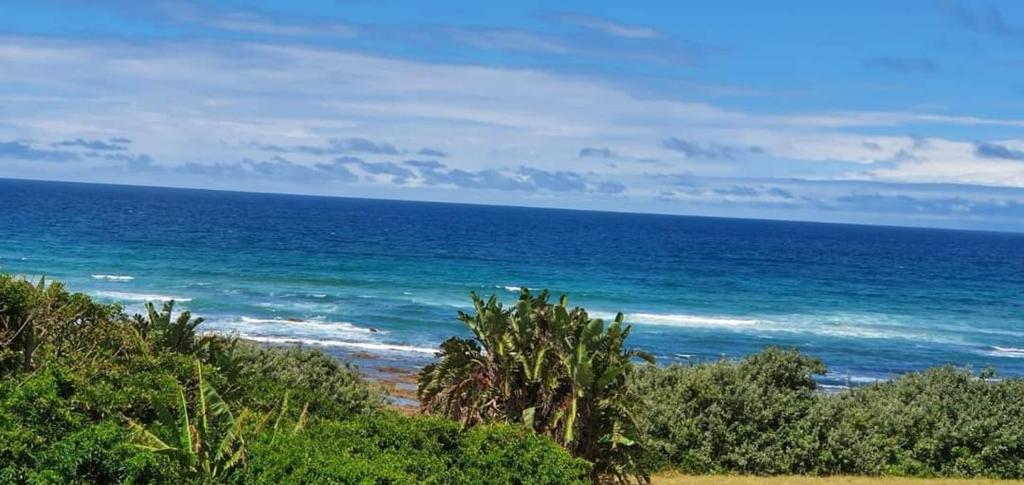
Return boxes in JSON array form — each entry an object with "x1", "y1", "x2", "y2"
[{"x1": 0, "y1": 0, "x2": 1024, "y2": 231}]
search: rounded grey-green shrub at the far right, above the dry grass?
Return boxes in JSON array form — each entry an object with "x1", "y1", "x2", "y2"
[{"x1": 807, "y1": 367, "x2": 1024, "y2": 478}]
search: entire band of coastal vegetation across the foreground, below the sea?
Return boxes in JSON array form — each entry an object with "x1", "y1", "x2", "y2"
[{"x1": 0, "y1": 275, "x2": 1024, "y2": 483}]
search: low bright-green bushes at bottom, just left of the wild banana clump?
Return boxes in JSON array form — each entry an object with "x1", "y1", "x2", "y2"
[{"x1": 234, "y1": 413, "x2": 589, "y2": 484}]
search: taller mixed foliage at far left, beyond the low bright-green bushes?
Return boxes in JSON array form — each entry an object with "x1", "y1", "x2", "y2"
[{"x1": 0, "y1": 275, "x2": 382, "y2": 483}]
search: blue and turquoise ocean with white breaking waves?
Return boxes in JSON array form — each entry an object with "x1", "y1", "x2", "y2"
[{"x1": 0, "y1": 180, "x2": 1024, "y2": 385}]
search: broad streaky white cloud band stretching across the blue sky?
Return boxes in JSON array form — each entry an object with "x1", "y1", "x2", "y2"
[{"x1": 0, "y1": 36, "x2": 1024, "y2": 194}]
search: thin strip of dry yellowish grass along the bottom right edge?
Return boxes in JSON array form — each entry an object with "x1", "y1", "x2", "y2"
[{"x1": 652, "y1": 473, "x2": 1024, "y2": 485}]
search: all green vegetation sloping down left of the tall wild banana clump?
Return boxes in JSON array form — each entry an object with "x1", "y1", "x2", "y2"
[{"x1": 0, "y1": 275, "x2": 590, "y2": 484}]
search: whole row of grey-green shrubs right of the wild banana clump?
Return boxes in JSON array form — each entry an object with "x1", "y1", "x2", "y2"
[{"x1": 631, "y1": 348, "x2": 1024, "y2": 478}]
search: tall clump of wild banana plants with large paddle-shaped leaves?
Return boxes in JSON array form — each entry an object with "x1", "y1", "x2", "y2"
[{"x1": 418, "y1": 289, "x2": 652, "y2": 479}]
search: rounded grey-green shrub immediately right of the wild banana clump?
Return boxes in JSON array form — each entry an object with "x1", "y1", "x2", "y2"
[{"x1": 631, "y1": 349, "x2": 824, "y2": 474}]
